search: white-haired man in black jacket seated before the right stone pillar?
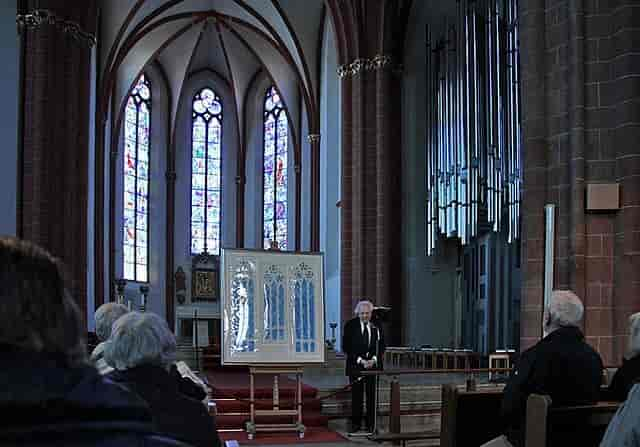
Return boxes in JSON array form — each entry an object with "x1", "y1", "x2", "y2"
[{"x1": 485, "y1": 290, "x2": 603, "y2": 446}]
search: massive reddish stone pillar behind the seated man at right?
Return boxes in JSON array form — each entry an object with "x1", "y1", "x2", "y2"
[{"x1": 520, "y1": 0, "x2": 640, "y2": 364}]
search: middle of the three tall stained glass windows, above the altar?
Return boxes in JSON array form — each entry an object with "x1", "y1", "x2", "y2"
[{"x1": 191, "y1": 87, "x2": 222, "y2": 255}]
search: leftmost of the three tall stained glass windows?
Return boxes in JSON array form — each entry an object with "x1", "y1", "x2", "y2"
[{"x1": 122, "y1": 74, "x2": 151, "y2": 282}]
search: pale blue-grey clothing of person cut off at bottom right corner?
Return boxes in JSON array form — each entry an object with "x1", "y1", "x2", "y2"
[{"x1": 600, "y1": 383, "x2": 640, "y2": 447}]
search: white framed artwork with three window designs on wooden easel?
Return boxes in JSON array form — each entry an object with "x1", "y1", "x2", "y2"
[{"x1": 221, "y1": 249, "x2": 325, "y2": 364}]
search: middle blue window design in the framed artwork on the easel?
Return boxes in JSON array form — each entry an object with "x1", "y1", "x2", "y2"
[{"x1": 264, "y1": 265, "x2": 285, "y2": 343}]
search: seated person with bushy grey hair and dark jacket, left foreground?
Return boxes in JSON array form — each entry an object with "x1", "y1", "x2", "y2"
[{"x1": 104, "y1": 312, "x2": 220, "y2": 447}]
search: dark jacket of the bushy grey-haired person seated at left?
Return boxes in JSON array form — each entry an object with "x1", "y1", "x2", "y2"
[{"x1": 107, "y1": 365, "x2": 221, "y2": 447}]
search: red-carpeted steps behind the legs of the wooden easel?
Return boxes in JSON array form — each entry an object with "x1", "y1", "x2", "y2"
[{"x1": 205, "y1": 367, "x2": 331, "y2": 432}]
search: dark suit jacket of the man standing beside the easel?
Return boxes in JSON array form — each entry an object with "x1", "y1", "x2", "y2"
[{"x1": 342, "y1": 318, "x2": 385, "y2": 376}]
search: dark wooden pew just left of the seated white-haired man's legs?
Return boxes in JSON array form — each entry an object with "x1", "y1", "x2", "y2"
[{"x1": 440, "y1": 384, "x2": 503, "y2": 447}]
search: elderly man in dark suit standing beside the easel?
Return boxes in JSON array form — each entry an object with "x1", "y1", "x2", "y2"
[{"x1": 342, "y1": 300, "x2": 385, "y2": 433}]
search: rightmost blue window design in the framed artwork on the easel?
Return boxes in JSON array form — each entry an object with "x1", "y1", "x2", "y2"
[{"x1": 292, "y1": 262, "x2": 316, "y2": 352}]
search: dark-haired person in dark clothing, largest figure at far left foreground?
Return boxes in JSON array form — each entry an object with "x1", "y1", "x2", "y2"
[{"x1": 0, "y1": 237, "x2": 170, "y2": 446}]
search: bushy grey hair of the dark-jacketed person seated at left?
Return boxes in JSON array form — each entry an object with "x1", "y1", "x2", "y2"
[{"x1": 104, "y1": 312, "x2": 177, "y2": 370}]
